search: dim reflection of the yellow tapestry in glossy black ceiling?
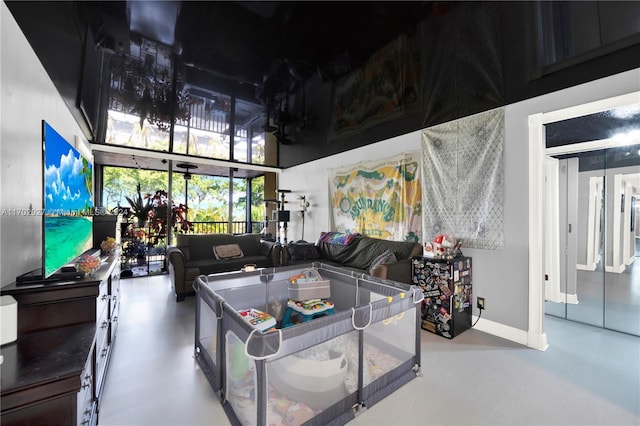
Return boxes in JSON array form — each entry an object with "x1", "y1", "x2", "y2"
[{"x1": 329, "y1": 33, "x2": 420, "y2": 140}]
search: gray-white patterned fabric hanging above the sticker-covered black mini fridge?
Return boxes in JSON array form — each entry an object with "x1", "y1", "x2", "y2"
[{"x1": 422, "y1": 108, "x2": 504, "y2": 250}]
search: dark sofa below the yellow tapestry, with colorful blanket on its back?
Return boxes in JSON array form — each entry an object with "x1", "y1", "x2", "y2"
[{"x1": 282, "y1": 232, "x2": 422, "y2": 284}]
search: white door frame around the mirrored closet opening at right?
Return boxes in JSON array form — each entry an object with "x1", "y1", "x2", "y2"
[{"x1": 527, "y1": 91, "x2": 640, "y2": 350}]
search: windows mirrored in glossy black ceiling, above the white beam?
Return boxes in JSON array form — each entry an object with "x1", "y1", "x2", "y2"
[{"x1": 105, "y1": 39, "x2": 265, "y2": 164}]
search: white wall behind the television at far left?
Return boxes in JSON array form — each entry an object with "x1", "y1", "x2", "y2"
[{"x1": 0, "y1": 2, "x2": 82, "y2": 286}]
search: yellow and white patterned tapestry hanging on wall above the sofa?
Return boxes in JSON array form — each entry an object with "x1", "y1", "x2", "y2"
[{"x1": 329, "y1": 151, "x2": 422, "y2": 242}]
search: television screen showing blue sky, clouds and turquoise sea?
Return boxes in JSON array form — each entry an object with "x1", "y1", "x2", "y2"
[{"x1": 42, "y1": 120, "x2": 93, "y2": 278}]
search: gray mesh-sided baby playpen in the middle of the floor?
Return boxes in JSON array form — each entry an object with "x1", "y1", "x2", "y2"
[{"x1": 194, "y1": 263, "x2": 423, "y2": 425}]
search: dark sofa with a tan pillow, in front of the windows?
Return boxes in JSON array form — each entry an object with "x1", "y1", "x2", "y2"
[{"x1": 167, "y1": 234, "x2": 281, "y2": 302}]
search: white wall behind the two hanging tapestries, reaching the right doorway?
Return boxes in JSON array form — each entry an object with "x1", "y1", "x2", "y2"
[{"x1": 279, "y1": 69, "x2": 640, "y2": 346}]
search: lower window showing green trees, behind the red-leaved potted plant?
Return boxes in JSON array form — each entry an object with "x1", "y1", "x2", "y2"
[{"x1": 101, "y1": 166, "x2": 266, "y2": 275}]
